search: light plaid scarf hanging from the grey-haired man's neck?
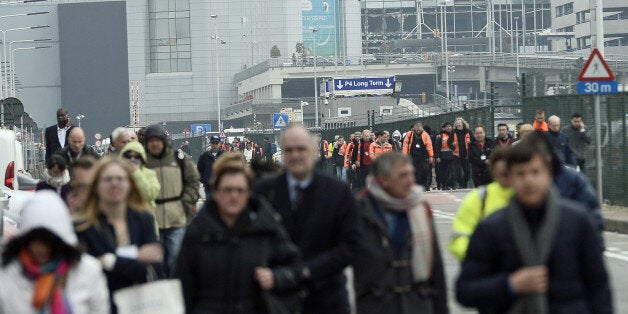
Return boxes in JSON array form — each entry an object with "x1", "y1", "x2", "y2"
[{"x1": 366, "y1": 176, "x2": 434, "y2": 282}]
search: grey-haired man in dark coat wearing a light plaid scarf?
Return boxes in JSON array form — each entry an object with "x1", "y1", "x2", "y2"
[{"x1": 353, "y1": 152, "x2": 449, "y2": 314}]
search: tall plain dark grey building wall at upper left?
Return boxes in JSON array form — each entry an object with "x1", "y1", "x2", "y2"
[{"x1": 59, "y1": 1, "x2": 129, "y2": 144}]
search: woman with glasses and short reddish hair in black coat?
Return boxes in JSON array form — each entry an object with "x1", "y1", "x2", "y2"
[{"x1": 174, "y1": 154, "x2": 301, "y2": 314}]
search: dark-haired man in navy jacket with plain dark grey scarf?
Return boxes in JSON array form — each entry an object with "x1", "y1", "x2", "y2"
[{"x1": 456, "y1": 137, "x2": 613, "y2": 314}]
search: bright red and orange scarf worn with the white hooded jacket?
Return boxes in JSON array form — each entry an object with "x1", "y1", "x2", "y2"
[{"x1": 20, "y1": 249, "x2": 72, "y2": 314}]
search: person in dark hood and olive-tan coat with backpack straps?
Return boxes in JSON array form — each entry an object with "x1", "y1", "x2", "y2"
[{"x1": 145, "y1": 125, "x2": 200, "y2": 275}]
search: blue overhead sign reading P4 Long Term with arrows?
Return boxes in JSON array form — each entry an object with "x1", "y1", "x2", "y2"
[{"x1": 334, "y1": 76, "x2": 395, "y2": 96}]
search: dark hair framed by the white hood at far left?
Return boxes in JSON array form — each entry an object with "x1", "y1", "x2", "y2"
[{"x1": 2, "y1": 228, "x2": 81, "y2": 266}]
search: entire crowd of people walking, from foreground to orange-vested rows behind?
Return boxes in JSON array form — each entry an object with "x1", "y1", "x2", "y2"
[{"x1": 0, "y1": 109, "x2": 613, "y2": 314}]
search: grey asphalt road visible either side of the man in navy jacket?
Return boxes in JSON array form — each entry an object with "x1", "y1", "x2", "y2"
[{"x1": 426, "y1": 190, "x2": 628, "y2": 314}]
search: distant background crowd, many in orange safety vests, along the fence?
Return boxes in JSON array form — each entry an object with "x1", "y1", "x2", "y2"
[{"x1": 318, "y1": 111, "x2": 591, "y2": 191}]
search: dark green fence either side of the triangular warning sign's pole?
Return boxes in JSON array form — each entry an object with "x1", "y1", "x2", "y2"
[{"x1": 522, "y1": 93, "x2": 628, "y2": 206}]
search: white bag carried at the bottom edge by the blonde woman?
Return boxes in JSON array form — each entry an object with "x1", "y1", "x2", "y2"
[{"x1": 113, "y1": 279, "x2": 185, "y2": 314}]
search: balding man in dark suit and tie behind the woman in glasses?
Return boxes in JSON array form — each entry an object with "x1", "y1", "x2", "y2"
[{"x1": 255, "y1": 125, "x2": 360, "y2": 314}]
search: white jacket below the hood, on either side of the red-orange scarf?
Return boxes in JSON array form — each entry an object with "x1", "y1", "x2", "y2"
[{"x1": 0, "y1": 254, "x2": 110, "y2": 314}]
